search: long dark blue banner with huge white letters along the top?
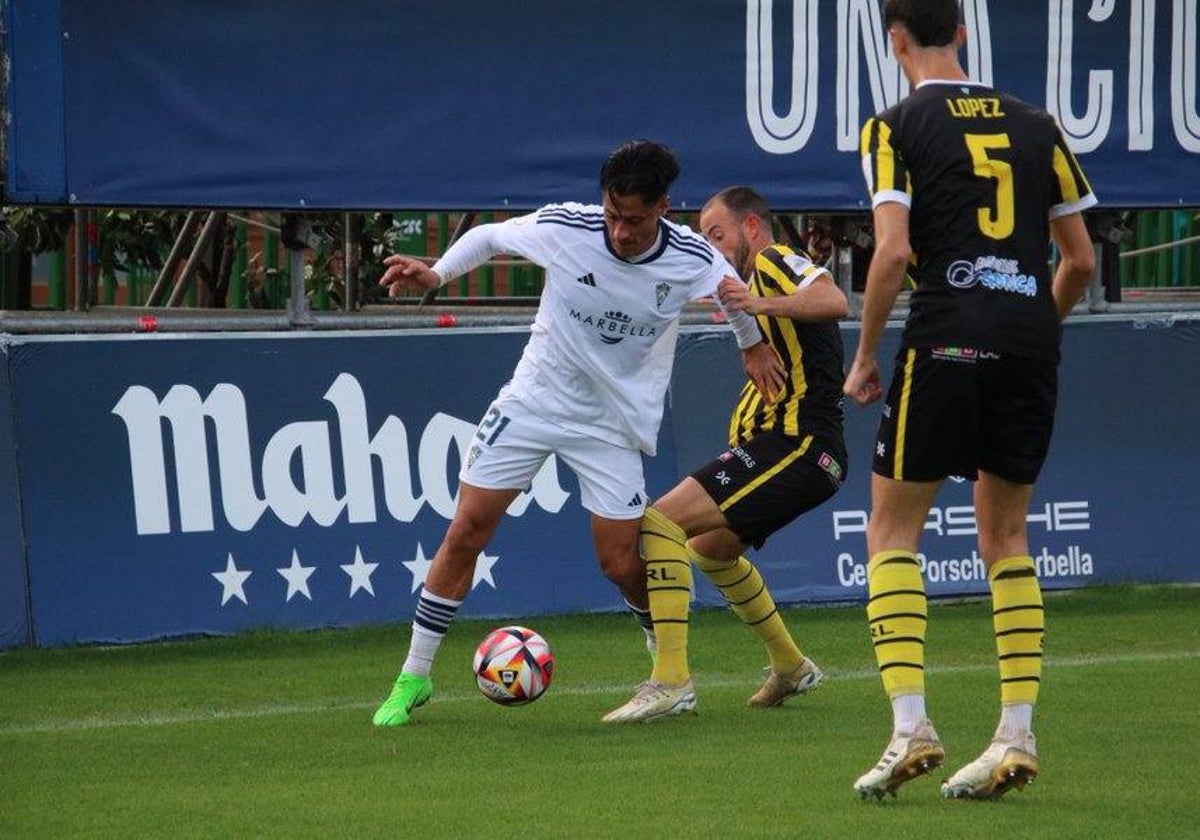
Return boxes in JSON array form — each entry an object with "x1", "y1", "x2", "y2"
[{"x1": 7, "y1": 0, "x2": 1200, "y2": 210}]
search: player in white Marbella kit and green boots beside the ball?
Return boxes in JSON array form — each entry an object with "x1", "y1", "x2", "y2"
[{"x1": 374, "y1": 140, "x2": 784, "y2": 726}]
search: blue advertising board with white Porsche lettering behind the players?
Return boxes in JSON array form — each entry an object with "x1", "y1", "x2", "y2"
[{"x1": 671, "y1": 318, "x2": 1200, "y2": 606}]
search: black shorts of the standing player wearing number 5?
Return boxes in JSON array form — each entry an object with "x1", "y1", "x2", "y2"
[{"x1": 872, "y1": 347, "x2": 1058, "y2": 484}]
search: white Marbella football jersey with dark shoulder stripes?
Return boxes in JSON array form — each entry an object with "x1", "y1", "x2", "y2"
[{"x1": 433, "y1": 203, "x2": 761, "y2": 455}]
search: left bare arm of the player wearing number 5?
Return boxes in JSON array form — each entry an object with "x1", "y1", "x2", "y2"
[{"x1": 842, "y1": 202, "x2": 912, "y2": 406}]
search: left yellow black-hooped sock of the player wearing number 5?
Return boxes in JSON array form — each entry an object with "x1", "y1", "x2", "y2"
[{"x1": 866, "y1": 551, "x2": 928, "y2": 698}]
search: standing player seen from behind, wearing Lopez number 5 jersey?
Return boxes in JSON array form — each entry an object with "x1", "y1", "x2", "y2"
[{"x1": 845, "y1": 0, "x2": 1096, "y2": 798}]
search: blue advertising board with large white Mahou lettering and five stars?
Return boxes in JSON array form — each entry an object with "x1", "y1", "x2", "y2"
[{"x1": 11, "y1": 330, "x2": 686, "y2": 646}]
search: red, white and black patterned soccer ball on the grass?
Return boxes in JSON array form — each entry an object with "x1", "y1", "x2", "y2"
[{"x1": 475, "y1": 626, "x2": 554, "y2": 706}]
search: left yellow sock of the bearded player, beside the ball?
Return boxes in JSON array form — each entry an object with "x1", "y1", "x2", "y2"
[{"x1": 642, "y1": 508, "x2": 691, "y2": 685}]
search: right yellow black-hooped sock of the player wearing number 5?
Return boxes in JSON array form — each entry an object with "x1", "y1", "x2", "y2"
[{"x1": 988, "y1": 554, "x2": 1045, "y2": 706}]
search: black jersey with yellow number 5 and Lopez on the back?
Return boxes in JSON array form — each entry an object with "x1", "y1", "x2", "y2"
[{"x1": 862, "y1": 80, "x2": 1096, "y2": 360}]
